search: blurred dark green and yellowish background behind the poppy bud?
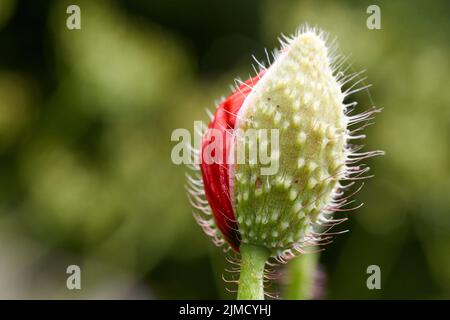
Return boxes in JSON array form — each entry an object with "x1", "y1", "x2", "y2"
[{"x1": 0, "y1": 0, "x2": 450, "y2": 299}]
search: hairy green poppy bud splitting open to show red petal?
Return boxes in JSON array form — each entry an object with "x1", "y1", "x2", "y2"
[{"x1": 189, "y1": 28, "x2": 381, "y2": 261}]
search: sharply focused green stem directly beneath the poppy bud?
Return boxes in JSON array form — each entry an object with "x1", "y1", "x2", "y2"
[{"x1": 237, "y1": 243, "x2": 270, "y2": 300}]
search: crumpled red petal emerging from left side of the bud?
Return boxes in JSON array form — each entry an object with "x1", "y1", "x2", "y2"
[{"x1": 200, "y1": 72, "x2": 264, "y2": 251}]
